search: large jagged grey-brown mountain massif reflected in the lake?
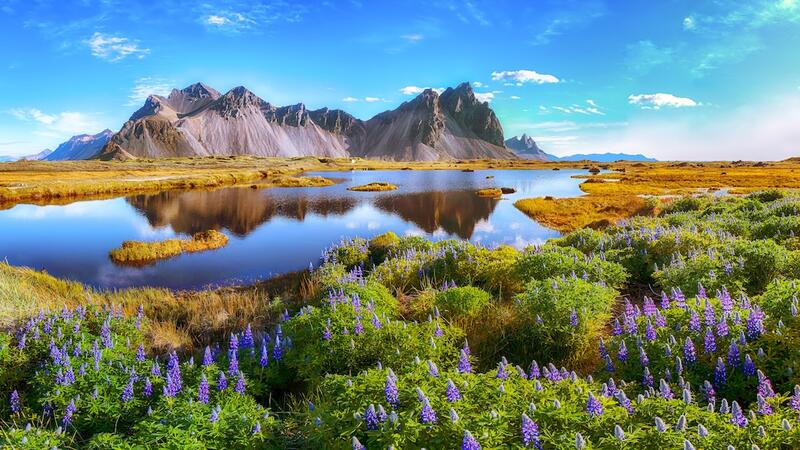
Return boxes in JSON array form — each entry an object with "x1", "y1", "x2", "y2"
[{"x1": 94, "y1": 83, "x2": 515, "y2": 161}]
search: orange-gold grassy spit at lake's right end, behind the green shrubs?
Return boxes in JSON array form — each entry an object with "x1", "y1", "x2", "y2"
[{"x1": 514, "y1": 195, "x2": 653, "y2": 232}]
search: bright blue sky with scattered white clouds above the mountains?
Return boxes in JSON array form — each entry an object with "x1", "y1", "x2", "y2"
[{"x1": 0, "y1": 0, "x2": 800, "y2": 159}]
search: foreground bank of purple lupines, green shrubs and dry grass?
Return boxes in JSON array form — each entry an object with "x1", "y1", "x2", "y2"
[{"x1": 7, "y1": 191, "x2": 800, "y2": 450}]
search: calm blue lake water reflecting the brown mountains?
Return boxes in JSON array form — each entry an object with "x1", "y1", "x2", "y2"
[{"x1": 0, "y1": 170, "x2": 585, "y2": 289}]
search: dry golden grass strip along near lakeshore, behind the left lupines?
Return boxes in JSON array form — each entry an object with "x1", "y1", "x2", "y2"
[{"x1": 0, "y1": 263, "x2": 317, "y2": 350}]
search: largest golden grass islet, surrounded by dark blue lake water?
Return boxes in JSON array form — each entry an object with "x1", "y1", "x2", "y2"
[{"x1": 108, "y1": 230, "x2": 228, "y2": 265}]
